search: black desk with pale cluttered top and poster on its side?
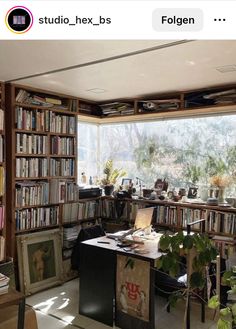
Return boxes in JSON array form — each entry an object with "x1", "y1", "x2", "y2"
[{"x1": 79, "y1": 237, "x2": 161, "y2": 329}]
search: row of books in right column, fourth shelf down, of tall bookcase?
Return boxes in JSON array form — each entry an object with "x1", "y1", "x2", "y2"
[{"x1": 50, "y1": 158, "x2": 75, "y2": 176}]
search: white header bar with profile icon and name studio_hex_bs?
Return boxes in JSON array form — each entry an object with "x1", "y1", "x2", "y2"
[{"x1": 0, "y1": 1, "x2": 236, "y2": 40}]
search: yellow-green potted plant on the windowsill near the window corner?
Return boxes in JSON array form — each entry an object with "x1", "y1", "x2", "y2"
[{"x1": 101, "y1": 159, "x2": 126, "y2": 195}]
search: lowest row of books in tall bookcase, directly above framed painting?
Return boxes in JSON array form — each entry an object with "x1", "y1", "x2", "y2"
[{"x1": 15, "y1": 206, "x2": 59, "y2": 231}]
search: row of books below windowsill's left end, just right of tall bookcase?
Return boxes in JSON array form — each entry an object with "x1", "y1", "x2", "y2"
[{"x1": 62, "y1": 201, "x2": 99, "y2": 224}]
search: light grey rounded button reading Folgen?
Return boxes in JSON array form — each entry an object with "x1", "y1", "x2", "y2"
[{"x1": 152, "y1": 8, "x2": 203, "y2": 32}]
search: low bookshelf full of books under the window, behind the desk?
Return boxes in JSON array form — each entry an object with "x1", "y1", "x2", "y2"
[{"x1": 101, "y1": 197, "x2": 236, "y2": 258}]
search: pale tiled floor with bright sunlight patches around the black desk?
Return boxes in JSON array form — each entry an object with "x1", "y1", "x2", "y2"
[{"x1": 26, "y1": 279, "x2": 216, "y2": 329}]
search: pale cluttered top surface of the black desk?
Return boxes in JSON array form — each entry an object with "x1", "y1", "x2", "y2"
[{"x1": 82, "y1": 236, "x2": 162, "y2": 260}]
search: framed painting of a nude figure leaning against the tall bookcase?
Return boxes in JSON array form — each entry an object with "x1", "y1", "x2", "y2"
[{"x1": 17, "y1": 229, "x2": 62, "y2": 295}]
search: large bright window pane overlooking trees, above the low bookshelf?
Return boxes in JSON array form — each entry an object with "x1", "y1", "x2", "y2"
[{"x1": 79, "y1": 115, "x2": 236, "y2": 193}]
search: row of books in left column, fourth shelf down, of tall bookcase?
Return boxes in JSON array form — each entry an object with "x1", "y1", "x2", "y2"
[{"x1": 16, "y1": 157, "x2": 48, "y2": 178}]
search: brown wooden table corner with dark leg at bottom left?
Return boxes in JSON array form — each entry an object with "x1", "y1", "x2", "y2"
[{"x1": 0, "y1": 289, "x2": 25, "y2": 329}]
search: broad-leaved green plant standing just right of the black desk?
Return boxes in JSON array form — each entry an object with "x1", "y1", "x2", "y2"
[{"x1": 156, "y1": 232, "x2": 218, "y2": 321}]
